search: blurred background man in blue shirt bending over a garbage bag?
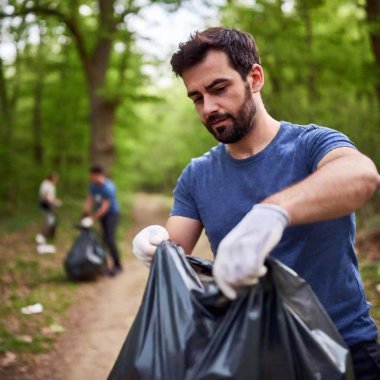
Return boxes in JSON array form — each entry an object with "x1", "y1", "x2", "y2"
[{"x1": 81, "y1": 166, "x2": 123, "y2": 276}]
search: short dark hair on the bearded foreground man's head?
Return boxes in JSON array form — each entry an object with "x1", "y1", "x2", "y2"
[{"x1": 170, "y1": 27, "x2": 260, "y2": 80}]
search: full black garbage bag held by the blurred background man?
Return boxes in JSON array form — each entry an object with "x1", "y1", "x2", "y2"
[{"x1": 64, "y1": 228, "x2": 106, "y2": 281}]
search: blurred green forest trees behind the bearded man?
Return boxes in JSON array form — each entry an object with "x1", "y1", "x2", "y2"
[{"x1": 0, "y1": 0, "x2": 380, "y2": 212}]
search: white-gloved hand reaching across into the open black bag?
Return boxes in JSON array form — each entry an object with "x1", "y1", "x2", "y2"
[{"x1": 213, "y1": 204, "x2": 289, "y2": 299}]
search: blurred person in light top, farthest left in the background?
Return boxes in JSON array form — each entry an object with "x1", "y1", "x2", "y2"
[{"x1": 35, "y1": 172, "x2": 62, "y2": 254}]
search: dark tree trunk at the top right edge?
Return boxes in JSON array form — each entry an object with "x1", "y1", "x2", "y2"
[{"x1": 366, "y1": 0, "x2": 380, "y2": 103}]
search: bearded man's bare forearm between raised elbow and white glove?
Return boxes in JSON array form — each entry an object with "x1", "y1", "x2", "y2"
[{"x1": 262, "y1": 153, "x2": 380, "y2": 225}]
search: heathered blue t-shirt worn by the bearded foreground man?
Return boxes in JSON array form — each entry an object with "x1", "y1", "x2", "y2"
[{"x1": 171, "y1": 122, "x2": 377, "y2": 345}]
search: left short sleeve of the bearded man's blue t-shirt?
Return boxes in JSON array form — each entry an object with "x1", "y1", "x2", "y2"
[{"x1": 170, "y1": 164, "x2": 200, "y2": 220}]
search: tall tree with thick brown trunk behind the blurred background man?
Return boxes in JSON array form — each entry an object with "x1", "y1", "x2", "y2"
[{"x1": 0, "y1": 0, "x2": 181, "y2": 170}]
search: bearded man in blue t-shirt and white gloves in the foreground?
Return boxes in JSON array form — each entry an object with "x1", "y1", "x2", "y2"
[{"x1": 133, "y1": 28, "x2": 380, "y2": 379}]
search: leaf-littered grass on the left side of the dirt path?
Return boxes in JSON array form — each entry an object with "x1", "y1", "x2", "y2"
[{"x1": 0, "y1": 197, "x2": 130, "y2": 360}]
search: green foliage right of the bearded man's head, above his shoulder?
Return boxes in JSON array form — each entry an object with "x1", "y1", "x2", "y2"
[{"x1": 222, "y1": 0, "x2": 380, "y2": 164}]
